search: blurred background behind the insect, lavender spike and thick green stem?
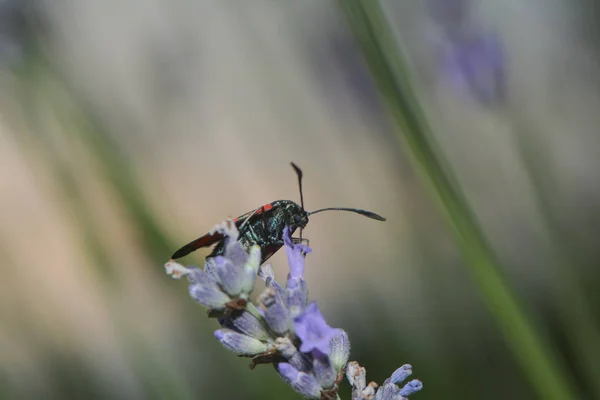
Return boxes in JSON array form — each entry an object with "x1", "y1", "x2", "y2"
[{"x1": 0, "y1": 0, "x2": 600, "y2": 400}]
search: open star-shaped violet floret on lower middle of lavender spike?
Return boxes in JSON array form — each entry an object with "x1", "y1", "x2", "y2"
[{"x1": 294, "y1": 303, "x2": 341, "y2": 355}]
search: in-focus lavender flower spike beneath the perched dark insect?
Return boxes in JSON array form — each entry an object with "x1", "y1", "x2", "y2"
[{"x1": 165, "y1": 220, "x2": 422, "y2": 400}]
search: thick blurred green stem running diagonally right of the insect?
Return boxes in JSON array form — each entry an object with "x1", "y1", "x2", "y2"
[{"x1": 339, "y1": 0, "x2": 576, "y2": 400}]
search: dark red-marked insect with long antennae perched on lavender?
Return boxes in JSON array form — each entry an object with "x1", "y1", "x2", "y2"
[{"x1": 171, "y1": 163, "x2": 385, "y2": 264}]
